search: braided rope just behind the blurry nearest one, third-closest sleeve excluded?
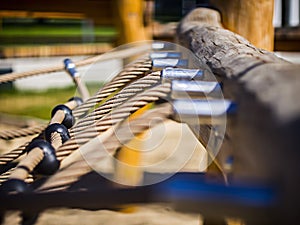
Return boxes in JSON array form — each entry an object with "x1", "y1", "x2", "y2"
[{"x1": 56, "y1": 83, "x2": 170, "y2": 160}]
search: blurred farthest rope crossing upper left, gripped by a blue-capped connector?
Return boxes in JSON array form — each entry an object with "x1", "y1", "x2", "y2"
[{"x1": 0, "y1": 46, "x2": 150, "y2": 83}]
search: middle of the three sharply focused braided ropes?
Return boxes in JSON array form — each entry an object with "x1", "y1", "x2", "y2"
[{"x1": 70, "y1": 72, "x2": 160, "y2": 133}]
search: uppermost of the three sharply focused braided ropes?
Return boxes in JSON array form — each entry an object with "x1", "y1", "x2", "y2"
[{"x1": 73, "y1": 59, "x2": 151, "y2": 118}]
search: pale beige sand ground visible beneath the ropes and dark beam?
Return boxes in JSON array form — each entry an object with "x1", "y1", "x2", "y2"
[{"x1": 0, "y1": 118, "x2": 225, "y2": 225}]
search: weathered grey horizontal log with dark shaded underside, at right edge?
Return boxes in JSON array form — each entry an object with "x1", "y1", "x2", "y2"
[{"x1": 178, "y1": 8, "x2": 300, "y2": 224}]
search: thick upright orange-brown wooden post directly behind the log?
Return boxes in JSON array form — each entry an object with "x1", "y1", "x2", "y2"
[{"x1": 211, "y1": 0, "x2": 274, "y2": 51}]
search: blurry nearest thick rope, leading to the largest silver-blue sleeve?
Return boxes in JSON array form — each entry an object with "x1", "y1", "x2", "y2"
[{"x1": 37, "y1": 103, "x2": 172, "y2": 192}]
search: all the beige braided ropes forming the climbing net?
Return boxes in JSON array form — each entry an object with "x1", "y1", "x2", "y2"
[{"x1": 0, "y1": 48, "x2": 176, "y2": 191}]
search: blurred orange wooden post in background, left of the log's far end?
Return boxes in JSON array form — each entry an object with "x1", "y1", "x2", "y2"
[{"x1": 114, "y1": 0, "x2": 147, "y2": 44}]
